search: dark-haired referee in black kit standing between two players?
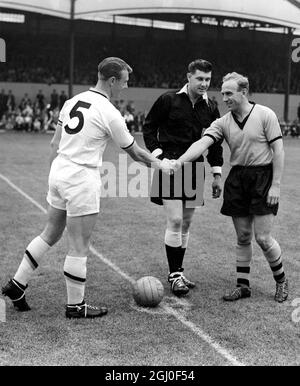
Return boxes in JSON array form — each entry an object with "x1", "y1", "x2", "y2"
[{"x1": 143, "y1": 59, "x2": 223, "y2": 296}]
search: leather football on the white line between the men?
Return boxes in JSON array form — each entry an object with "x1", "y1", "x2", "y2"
[{"x1": 133, "y1": 276, "x2": 164, "y2": 307}]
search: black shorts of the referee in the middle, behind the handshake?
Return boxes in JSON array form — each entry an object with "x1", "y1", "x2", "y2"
[{"x1": 150, "y1": 153, "x2": 205, "y2": 208}]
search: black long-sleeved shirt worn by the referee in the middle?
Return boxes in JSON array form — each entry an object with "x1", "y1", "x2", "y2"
[{"x1": 143, "y1": 91, "x2": 223, "y2": 167}]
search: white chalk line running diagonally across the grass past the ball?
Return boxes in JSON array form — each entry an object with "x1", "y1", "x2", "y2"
[{"x1": 0, "y1": 173, "x2": 246, "y2": 366}]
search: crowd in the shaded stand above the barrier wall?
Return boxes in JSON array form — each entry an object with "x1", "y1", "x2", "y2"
[{"x1": 0, "y1": 37, "x2": 300, "y2": 94}]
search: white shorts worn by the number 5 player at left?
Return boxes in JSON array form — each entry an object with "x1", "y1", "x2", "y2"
[{"x1": 47, "y1": 155, "x2": 101, "y2": 217}]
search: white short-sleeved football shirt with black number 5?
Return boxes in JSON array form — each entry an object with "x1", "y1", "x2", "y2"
[{"x1": 58, "y1": 88, "x2": 134, "y2": 167}]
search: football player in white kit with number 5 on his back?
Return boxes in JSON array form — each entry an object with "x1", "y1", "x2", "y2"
[{"x1": 2, "y1": 57, "x2": 168, "y2": 318}]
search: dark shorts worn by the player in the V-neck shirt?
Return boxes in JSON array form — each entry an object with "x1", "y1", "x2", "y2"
[{"x1": 221, "y1": 164, "x2": 278, "y2": 217}]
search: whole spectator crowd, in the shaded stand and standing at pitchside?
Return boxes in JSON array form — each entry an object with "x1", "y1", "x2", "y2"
[{"x1": 0, "y1": 36, "x2": 300, "y2": 137}]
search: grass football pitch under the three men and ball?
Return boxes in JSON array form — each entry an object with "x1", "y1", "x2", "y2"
[{"x1": 0, "y1": 133, "x2": 300, "y2": 366}]
